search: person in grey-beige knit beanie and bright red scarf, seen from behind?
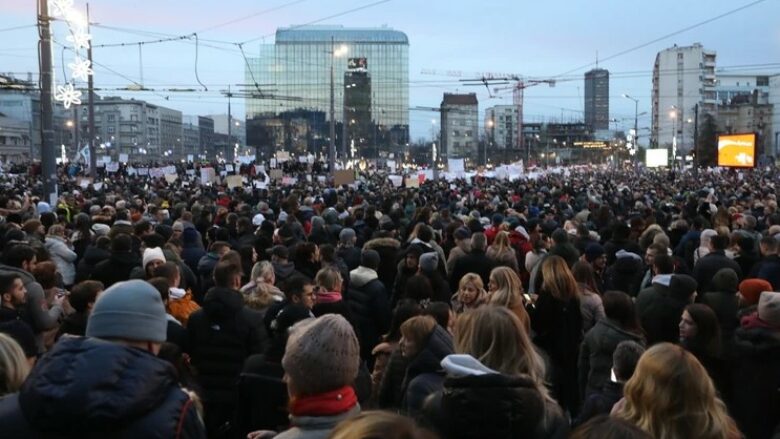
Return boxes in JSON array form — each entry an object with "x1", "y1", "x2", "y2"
[{"x1": 266, "y1": 314, "x2": 360, "y2": 439}]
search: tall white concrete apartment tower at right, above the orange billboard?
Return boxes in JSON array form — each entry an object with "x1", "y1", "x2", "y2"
[{"x1": 651, "y1": 43, "x2": 718, "y2": 152}]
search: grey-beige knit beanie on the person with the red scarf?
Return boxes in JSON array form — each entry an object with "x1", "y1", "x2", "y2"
[{"x1": 282, "y1": 314, "x2": 360, "y2": 396}]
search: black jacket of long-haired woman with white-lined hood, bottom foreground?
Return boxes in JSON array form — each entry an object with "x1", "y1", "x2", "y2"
[{"x1": 425, "y1": 374, "x2": 568, "y2": 439}]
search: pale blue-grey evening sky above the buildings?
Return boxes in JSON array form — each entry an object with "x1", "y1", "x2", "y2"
[{"x1": 0, "y1": 0, "x2": 780, "y2": 139}]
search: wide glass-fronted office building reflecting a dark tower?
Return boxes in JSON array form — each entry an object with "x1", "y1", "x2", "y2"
[{"x1": 245, "y1": 26, "x2": 409, "y2": 157}]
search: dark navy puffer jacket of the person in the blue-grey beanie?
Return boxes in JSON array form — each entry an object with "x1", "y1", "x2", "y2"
[{"x1": 0, "y1": 337, "x2": 206, "y2": 439}]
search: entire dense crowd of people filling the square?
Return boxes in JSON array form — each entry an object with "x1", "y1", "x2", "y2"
[{"x1": 0, "y1": 164, "x2": 780, "y2": 439}]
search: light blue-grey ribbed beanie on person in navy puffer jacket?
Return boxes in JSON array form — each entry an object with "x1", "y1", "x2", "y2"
[{"x1": 86, "y1": 280, "x2": 168, "y2": 343}]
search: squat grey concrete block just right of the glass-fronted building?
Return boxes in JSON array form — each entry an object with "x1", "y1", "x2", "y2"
[{"x1": 439, "y1": 93, "x2": 479, "y2": 160}]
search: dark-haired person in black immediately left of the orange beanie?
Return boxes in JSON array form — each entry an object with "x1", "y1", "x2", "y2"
[{"x1": 700, "y1": 268, "x2": 739, "y2": 348}]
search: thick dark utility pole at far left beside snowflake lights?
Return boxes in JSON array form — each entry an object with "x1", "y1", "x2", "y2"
[{"x1": 38, "y1": 0, "x2": 57, "y2": 206}]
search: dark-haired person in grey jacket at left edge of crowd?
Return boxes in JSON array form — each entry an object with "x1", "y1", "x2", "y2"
[{"x1": 0, "y1": 244, "x2": 67, "y2": 352}]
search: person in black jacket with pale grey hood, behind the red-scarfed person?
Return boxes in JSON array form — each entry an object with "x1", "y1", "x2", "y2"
[{"x1": 347, "y1": 250, "x2": 391, "y2": 361}]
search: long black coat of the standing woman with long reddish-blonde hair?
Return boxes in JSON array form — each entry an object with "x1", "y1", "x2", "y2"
[{"x1": 531, "y1": 291, "x2": 582, "y2": 411}]
